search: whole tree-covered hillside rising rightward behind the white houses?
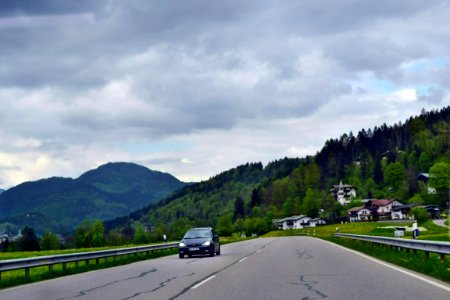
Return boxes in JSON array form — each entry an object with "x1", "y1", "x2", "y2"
[{"x1": 106, "y1": 107, "x2": 450, "y2": 238}]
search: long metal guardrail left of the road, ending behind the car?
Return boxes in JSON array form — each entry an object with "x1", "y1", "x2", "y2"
[{"x1": 0, "y1": 243, "x2": 178, "y2": 280}]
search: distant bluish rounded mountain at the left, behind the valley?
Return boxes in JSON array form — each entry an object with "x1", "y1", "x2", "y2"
[{"x1": 0, "y1": 162, "x2": 186, "y2": 232}]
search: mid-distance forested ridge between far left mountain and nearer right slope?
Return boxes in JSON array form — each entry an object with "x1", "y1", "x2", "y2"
[{"x1": 105, "y1": 158, "x2": 304, "y2": 234}]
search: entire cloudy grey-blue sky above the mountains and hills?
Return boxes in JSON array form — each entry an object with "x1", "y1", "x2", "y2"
[{"x1": 0, "y1": 0, "x2": 450, "y2": 188}]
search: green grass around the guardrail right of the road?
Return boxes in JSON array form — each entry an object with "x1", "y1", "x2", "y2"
[{"x1": 264, "y1": 221, "x2": 450, "y2": 283}]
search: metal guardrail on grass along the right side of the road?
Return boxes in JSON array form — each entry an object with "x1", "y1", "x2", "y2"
[{"x1": 333, "y1": 233, "x2": 450, "y2": 259}]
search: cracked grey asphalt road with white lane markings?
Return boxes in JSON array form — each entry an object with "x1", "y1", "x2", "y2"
[{"x1": 0, "y1": 237, "x2": 450, "y2": 300}]
